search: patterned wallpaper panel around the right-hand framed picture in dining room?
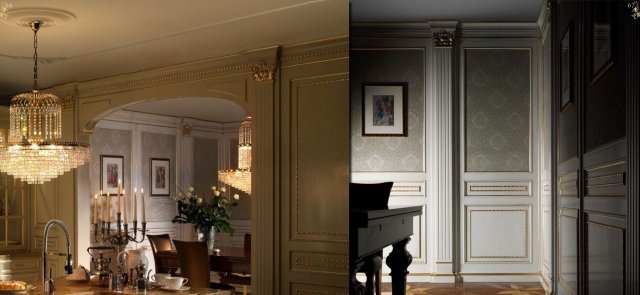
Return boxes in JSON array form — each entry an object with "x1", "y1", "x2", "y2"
[{"x1": 140, "y1": 132, "x2": 176, "y2": 221}]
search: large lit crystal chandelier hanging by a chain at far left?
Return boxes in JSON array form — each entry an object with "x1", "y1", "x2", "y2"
[{"x1": 0, "y1": 20, "x2": 89, "y2": 184}]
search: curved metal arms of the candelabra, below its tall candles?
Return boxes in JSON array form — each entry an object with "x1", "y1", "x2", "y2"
[{"x1": 93, "y1": 212, "x2": 147, "y2": 250}]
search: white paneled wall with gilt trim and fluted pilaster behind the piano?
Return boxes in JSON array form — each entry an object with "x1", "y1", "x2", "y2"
[{"x1": 350, "y1": 22, "x2": 550, "y2": 282}]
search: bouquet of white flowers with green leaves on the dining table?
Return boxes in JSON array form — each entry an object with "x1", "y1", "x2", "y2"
[{"x1": 171, "y1": 186, "x2": 240, "y2": 236}]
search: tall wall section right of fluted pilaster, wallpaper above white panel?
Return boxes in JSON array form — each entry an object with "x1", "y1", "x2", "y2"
[{"x1": 457, "y1": 38, "x2": 543, "y2": 282}]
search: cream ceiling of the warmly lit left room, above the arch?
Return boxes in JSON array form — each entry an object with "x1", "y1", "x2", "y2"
[{"x1": 0, "y1": 0, "x2": 348, "y2": 122}]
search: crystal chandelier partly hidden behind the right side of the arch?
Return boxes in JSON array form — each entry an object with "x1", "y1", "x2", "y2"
[{"x1": 218, "y1": 118, "x2": 251, "y2": 195}]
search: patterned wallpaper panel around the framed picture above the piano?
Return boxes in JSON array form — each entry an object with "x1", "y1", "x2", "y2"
[{"x1": 349, "y1": 49, "x2": 425, "y2": 172}]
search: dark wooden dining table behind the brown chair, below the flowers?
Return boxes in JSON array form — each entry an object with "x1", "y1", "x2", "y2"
[{"x1": 156, "y1": 247, "x2": 251, "y2": 274}]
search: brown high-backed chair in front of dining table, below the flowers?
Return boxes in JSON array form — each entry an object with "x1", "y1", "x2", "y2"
[{"x1": 173, "y1": 240, "x2": 235, "y2": 291}]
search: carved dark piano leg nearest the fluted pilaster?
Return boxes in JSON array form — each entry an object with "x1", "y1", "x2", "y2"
[{"x1": 387, "y1": 238, "x2": 413, "y2": 295}]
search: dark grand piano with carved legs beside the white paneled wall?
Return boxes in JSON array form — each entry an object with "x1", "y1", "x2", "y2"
[{"x1": 349, "y1": 182, "x2": 422, "y2": 295}]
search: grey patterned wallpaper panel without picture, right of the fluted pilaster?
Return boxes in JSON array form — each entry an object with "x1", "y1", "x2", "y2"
[{"x1": 465, "y1": 49, "x2": 531, "y2": 172}]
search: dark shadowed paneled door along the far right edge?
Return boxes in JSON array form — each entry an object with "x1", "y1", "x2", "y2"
[{"x1": 553, "y1": 1, "x2": 640, "y2": 294}]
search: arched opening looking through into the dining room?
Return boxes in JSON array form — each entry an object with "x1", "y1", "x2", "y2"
[{"x1": 77, "y1": 96, "x2": 251, "y2": 290}]
